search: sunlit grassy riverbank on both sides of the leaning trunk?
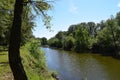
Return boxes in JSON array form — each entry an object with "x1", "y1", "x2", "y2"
[{"x1": 0, "y1": 43, "x2": 54, "y2": 80}]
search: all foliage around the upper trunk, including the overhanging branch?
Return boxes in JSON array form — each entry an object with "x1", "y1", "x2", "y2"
[{"x1": 0, "y1": 0, "x2": 53, "y2": 45}]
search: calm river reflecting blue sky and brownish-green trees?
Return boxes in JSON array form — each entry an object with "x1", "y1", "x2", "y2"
[{"x1": 42, "y1": 48, "x2": 120, "y2": 80}]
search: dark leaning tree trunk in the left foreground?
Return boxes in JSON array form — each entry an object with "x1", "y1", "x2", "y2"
[{"x1": 9, "y1": 0, "x2": 27, "y2": 80}]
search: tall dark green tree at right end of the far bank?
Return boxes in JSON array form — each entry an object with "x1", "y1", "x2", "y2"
[{"x1": 97, "y1": 18, "x2": 120, "y2": 55}]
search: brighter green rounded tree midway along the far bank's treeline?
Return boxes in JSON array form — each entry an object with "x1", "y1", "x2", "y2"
[{"x1": 75, "y1": 25, "x2": 89, "y2": 52}]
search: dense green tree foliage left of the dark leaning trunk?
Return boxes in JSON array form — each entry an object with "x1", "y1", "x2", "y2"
[{"x1": 0, "y1": 0, "x2": 14, "y2": 46}]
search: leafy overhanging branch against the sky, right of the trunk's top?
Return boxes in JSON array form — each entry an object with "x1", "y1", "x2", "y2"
[{"x1": 28, "y1": 0, "x2": 54, "y2": 28}]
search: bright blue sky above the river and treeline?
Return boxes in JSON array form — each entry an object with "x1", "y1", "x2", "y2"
[{"x1": 33, "y1": 0, "x2": 120, "y2": 39}]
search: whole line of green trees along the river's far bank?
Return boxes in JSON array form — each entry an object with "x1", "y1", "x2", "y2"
[{"x1": 41, "y1": 12, "x2": 120, "y2": 55}]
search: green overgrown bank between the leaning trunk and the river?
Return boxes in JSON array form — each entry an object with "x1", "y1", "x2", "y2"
[{"x1": 21, "y1": 40, "x2": 53, "y2": 80}]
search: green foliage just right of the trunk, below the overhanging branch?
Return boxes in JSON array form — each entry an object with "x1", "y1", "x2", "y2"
[{"x1": 21, "y1": 6, "x2": 35, "y2": 46}]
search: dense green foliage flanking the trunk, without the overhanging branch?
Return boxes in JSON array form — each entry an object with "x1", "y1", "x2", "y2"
[{"x1": 0, "y1": 0, "x2": 34, "y2": 46}]
